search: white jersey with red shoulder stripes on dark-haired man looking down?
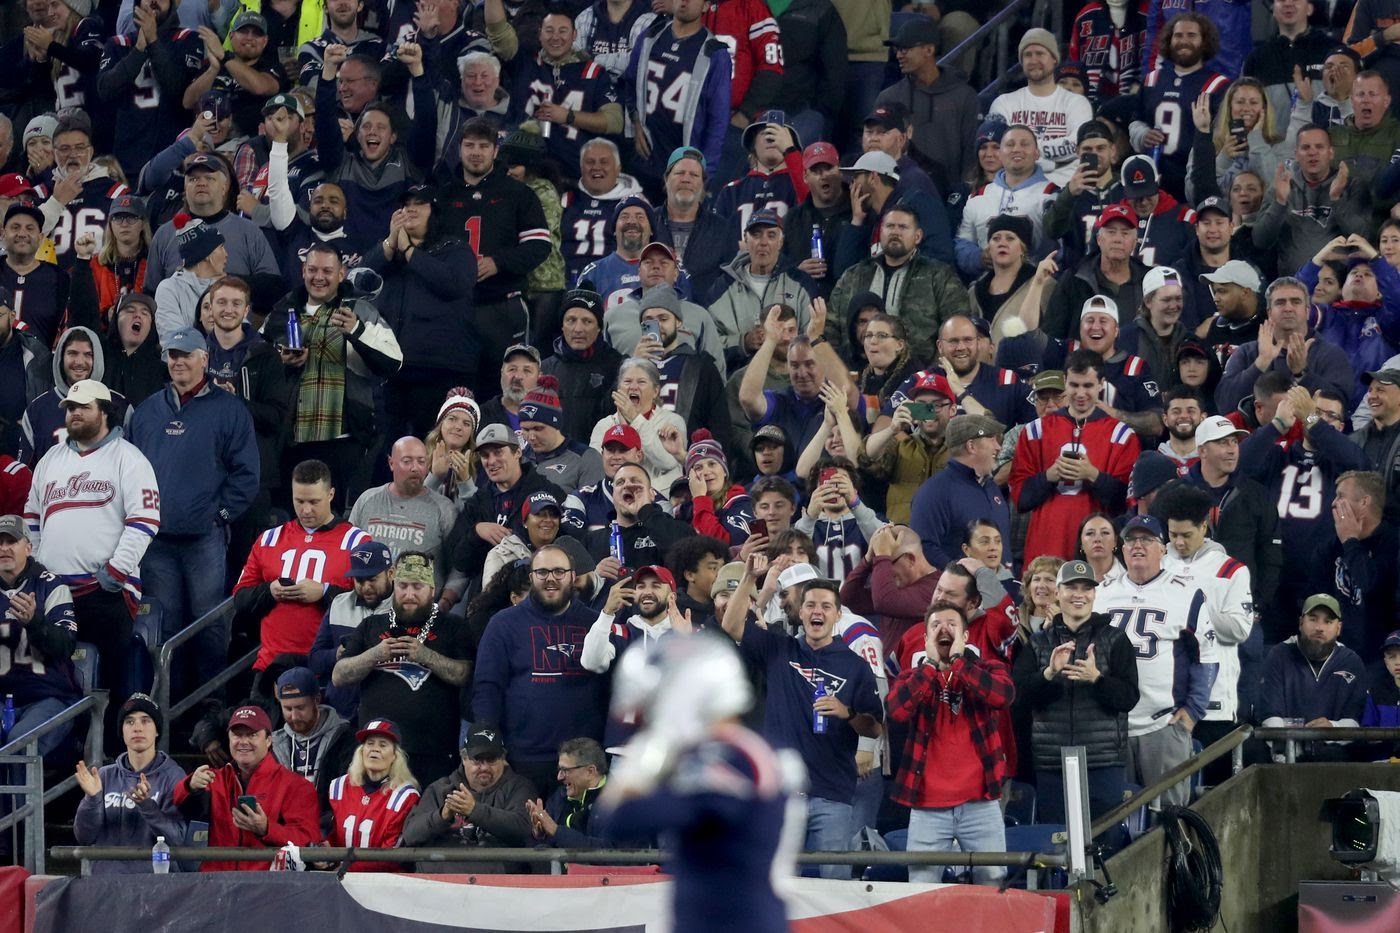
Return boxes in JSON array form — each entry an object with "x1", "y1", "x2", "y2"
[{"x1": 1162, "y1": 539, "x2": 1254, "y2": 721}]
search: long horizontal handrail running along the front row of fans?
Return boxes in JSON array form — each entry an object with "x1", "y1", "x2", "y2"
[{"x1": 49, "y1": 846, "x2": 1065, "y2": 869}]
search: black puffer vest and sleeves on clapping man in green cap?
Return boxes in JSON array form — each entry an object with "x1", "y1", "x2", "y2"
[{"x1": 1012, "y1": 612, "x2": 1138, "y2": 770}]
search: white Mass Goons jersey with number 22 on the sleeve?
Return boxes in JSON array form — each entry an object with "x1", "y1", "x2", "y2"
[{"x1": 24, "y1": 427, "x2": 161, "y2": 605}]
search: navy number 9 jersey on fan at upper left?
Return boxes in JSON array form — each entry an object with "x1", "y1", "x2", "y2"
[{"x1": 101, "y1": 29, "x2": 204, "y2": 178}]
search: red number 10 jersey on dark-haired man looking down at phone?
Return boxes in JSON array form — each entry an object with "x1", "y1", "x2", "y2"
[{"x1": 234, "y1": 518, "x2": 370, "y2": 671}]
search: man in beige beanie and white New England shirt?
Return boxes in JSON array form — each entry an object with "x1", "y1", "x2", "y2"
[{"x1": 988, "y1": 29, "x2": 1086, "y2": 185}]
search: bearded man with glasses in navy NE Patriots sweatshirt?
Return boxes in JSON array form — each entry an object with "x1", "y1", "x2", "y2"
[{"x1": 472, "y1": 545, "x2": 608, "y2": 799}]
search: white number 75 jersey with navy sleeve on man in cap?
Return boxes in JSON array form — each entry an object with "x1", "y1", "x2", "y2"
[{"x1": 1093, "y1": 570, "x2": 1218, "y2": 735}]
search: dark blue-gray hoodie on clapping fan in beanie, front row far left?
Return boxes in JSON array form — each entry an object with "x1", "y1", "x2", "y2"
[{"x1": 73, "y1": 752, "x2": 185, "y2": 874}]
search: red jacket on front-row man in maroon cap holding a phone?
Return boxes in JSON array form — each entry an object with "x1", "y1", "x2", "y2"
[{"x1": 175, "y1": 749, "x2": 321, "y2": 871}]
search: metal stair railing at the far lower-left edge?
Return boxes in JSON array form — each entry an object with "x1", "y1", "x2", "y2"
[{"x1": 0, "y1": 691, "x2": 106, "y2": 874}]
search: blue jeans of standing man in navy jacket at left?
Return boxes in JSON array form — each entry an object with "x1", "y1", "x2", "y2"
[{"x1": 141, "y1": 527, "x2": 230, "y2": 689}]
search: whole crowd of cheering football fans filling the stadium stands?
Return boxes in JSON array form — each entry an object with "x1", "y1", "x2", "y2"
[{"x1": 0, "y1": 0, "x2": 1400, "y2": 883}]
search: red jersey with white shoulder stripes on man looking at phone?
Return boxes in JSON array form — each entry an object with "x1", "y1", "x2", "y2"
[{"x1": 1011, "y1": 409, "x2": 1140, "y2": 562}]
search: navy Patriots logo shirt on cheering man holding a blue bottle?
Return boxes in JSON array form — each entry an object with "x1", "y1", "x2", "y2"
[{"x1": 739, "y1": 622, "x2": 885, "y2": 803}]
